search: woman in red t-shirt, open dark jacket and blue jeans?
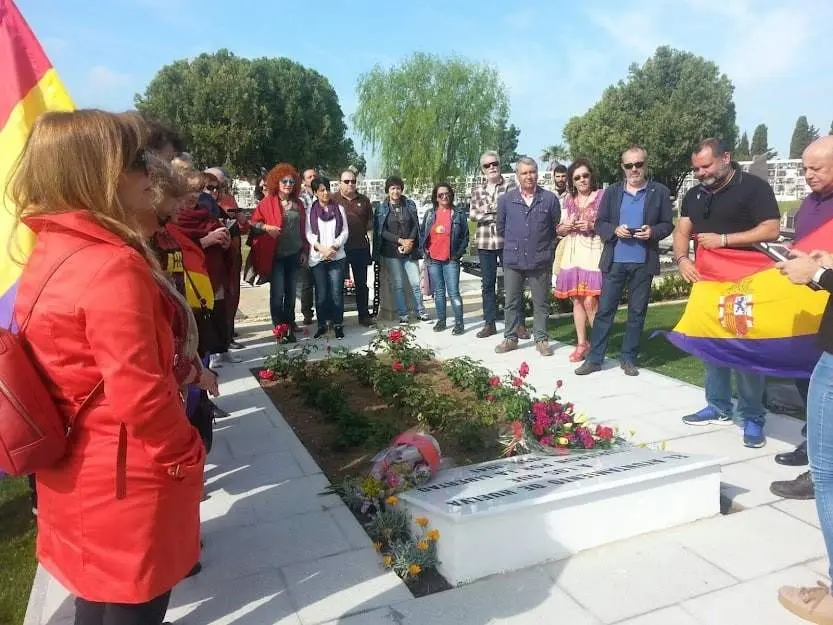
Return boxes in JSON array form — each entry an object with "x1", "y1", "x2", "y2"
[{"x1": 420, "y1": 182, "x2": 469, "y2": 335}]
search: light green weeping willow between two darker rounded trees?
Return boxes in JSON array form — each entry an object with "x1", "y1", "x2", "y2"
[{"x1": 353, "y1": 52, "x2": 509, "y2": 182}]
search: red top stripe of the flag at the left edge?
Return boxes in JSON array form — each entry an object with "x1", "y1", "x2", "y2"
[{"x1": 0, "y1": 0, "x2": 52, "y2": 128}]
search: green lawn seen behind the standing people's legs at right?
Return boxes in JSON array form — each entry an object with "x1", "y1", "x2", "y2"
[{"x1": 550, "y1": 304, "x2": 704, "y2": 386}]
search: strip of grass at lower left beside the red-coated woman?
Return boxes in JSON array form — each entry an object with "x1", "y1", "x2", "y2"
[{"x1": 0, "y1": 477, "x2": 37, "y2": 625}]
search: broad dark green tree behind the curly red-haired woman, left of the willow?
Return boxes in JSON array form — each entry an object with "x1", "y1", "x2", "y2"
[{"x1": 135, "y1": 50, "x2": 361, "y2": 175}]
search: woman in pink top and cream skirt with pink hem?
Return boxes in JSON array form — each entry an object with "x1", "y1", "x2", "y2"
[{"x1": 553, "y1": 158, "x2": 604, "y2": 362}]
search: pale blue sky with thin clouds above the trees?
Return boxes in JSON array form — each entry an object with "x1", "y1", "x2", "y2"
[{"x1": 16, "y1": 0, "x2": 833, "y2": 173}]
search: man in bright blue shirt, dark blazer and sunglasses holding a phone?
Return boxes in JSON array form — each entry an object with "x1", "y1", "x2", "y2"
[{"x1": 576, "y1": 146, "x2": 674, "y2": 375}]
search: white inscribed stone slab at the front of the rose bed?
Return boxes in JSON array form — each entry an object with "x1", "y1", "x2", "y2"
[{"x1": 401, "y1": 448, "x2": 720, "y2": 584}]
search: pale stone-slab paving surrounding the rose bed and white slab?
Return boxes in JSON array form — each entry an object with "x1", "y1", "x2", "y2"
[{"x1": 26, "y1": 300, "x2": 827, "y2": 625}]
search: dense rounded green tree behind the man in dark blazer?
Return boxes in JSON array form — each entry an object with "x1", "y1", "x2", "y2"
[{"x1": 564, "y1": 46, "x2": 737, "y2": 193}]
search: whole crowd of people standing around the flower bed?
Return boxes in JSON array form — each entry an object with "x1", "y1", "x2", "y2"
[{"x1": 10, "y1": 103, "x2": 833, "y2": 625}]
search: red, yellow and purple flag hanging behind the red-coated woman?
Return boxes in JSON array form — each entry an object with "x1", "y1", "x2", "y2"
[{"x1": 0, "y1": 0, "x2": 74, "y2": 327}]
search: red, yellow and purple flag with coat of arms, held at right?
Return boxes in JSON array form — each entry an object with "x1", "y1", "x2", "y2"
[{"x1": 665, "y1": 221, "x2": 833, "y2": 378}]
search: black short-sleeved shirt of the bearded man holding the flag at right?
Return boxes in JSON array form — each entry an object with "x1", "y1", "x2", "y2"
[{"x1": 680, "y1": 170, "x2": 781, "y2": 234}]
